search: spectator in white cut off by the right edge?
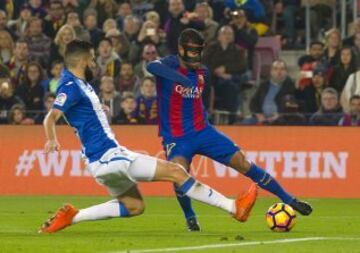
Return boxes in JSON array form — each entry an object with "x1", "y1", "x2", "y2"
[{"x1": 340, "y1": 68, "x2": 360, "y2": 112}]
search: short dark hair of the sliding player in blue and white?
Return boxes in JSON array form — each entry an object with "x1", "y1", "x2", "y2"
[{"x1": 64, "y1": 40, "x2": 94, "y2": 67}]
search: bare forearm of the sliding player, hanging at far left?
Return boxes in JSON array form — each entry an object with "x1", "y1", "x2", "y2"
[{"x1": 43, "y1": 108, "x2": 63, "y2": 153}]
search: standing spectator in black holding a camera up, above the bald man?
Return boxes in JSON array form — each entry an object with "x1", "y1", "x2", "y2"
[{"x1": 230, "y1": 9, "x2": 258, "y2": 69}]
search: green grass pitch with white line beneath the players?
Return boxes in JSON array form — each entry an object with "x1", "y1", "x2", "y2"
[{"x1": 0, "y1": 196, "x2": 360, "y2": 253}]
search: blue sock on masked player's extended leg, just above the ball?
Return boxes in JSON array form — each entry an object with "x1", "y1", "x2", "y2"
[{"x1": 245, "y1": 163, "x2": 294, "y2": 204}]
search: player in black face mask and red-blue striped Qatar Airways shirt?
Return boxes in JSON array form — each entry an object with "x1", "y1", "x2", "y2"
[{"x1": 147, "y1": 28, "x2": 312, "y2": 231}]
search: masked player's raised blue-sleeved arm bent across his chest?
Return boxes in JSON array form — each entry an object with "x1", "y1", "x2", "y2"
[{"x1": 146, "y1": 60, "x2": 192, "y2": 87}]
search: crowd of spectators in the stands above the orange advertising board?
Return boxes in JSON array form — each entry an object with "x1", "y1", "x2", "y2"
[{"x1": 0, "y1": 0, "x2": 360, "y2": 126}]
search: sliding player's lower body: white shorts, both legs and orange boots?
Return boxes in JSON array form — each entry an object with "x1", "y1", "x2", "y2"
[{"x1": 39, "y1": 149, "x2": 257, "y2": 233}]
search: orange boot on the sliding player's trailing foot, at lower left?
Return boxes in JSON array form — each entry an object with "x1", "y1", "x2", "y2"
[{"x1": 39, "y1": 204, "x2": 79, "y2": 233}]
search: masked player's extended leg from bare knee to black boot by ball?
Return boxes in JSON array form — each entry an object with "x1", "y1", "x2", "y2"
[{"x1": 229, "y1": 151, "x2": 312, "y2": 215}]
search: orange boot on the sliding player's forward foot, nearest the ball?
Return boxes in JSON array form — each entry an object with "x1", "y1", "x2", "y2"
[{"x1": 234, "y1": 183, "x2": 257, "y2": 222}]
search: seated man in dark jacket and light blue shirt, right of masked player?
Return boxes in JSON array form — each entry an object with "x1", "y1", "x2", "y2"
[{"x1": 243, "y1": 60, "x2": 295, "y2": 124}]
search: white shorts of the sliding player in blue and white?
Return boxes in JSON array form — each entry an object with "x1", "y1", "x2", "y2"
[{"x1": 87, "y1": 147, "x2": 157, "y2": 197}]
